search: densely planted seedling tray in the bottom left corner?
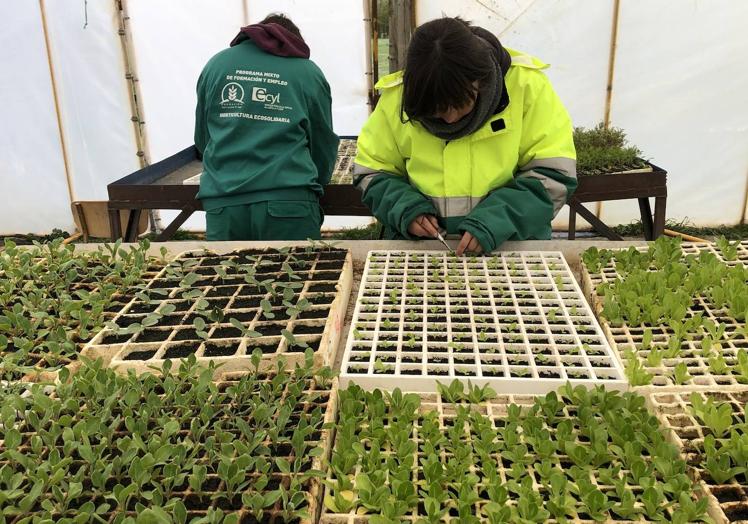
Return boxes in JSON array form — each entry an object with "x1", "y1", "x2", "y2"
[{"x1": 0, "y1": 358, "x2": 336, "y2": 523}]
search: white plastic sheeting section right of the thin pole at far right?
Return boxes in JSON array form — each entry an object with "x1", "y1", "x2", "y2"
[{"x1": 603, "y1": 0, "x2": 748, "y2": 224}]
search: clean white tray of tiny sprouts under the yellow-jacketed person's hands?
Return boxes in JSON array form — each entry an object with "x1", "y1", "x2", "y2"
[{"x1": 341, "y1": 251, "x2": 628, "y2": 394}]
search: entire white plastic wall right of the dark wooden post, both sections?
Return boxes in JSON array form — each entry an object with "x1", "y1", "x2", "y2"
[{"x1": 416, "y1": 0, "x2": 748, "y2": 225}]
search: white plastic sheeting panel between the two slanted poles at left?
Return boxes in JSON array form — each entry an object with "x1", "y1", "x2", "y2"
[{"x1": 44, "y1": 0, "x2": 140, "y2": 200}]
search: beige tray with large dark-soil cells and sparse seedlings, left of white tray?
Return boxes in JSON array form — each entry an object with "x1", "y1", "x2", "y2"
[{"x1": 86, "y1": 248, "x2": 352, "y2": 372}]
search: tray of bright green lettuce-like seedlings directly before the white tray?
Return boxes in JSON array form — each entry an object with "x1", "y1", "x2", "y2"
[{"x1": 321, "y1": 382, "x2": 707, "y2": 524}]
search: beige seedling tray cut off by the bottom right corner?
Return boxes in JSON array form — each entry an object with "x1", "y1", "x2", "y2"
[{"x1": 647, "y1": 387, "x2": 748, "y2": 524}]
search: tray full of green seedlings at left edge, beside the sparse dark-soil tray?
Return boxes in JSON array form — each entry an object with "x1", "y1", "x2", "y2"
[{"x1": 0, "y1": 238, "x2": 162, "y2": 380}]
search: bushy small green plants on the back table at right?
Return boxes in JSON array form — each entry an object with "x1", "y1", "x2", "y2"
[{"x1": 574, "y1": 124, "x2": 651, "y2": 176}]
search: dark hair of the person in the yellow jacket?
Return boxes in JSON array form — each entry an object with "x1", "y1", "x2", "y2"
[{"x1": 400, "y1": 17, "x2": 493, "y2": 120}]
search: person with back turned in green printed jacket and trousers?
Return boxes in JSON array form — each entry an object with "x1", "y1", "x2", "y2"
[{"x1": 195, "y1": 14, "x2": 338, "y2": 240}]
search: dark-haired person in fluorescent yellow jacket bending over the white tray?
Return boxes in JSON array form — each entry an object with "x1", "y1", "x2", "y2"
[{"x1": 354, "y1": 18, "x2": 577, "y2": 255}]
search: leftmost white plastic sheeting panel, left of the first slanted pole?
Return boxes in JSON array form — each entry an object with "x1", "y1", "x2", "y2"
[{"x1": 0, "y1": 0, "x2": 73, "y2": 234}]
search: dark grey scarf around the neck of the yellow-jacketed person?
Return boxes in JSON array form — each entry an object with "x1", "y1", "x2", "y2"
[{"x1": 419, "y1": 27, "x2": 512, "y2": 140}]
